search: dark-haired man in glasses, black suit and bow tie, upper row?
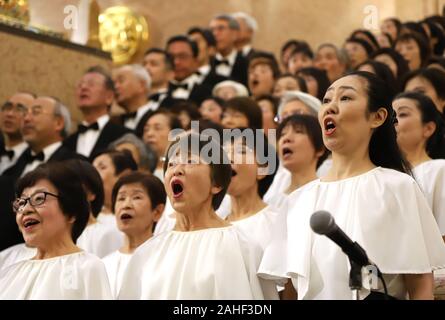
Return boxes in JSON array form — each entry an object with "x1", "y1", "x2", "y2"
[{"x1": 167, "y1": 35, "x2": 212, "y2": 105}]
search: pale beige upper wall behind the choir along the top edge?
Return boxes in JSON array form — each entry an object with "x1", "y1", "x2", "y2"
[{"x1": 29, "y1": 0, "x2": 445, "y2": 64}]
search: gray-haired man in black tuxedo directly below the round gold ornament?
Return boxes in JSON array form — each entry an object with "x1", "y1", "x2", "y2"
[{"x1": 113, "y1": 64, "x2": 154, "y2": 137}]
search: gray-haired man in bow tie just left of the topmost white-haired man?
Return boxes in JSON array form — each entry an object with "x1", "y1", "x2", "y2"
[{"x1": 210, "y1": 14, "x2": 247, "y2": 86}]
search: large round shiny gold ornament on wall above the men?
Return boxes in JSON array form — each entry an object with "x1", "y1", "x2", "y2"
[{"x1": 99, "y1": 6, "x2": 149, "y2": 64}]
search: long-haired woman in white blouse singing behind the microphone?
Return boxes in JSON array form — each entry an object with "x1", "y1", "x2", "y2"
[{"x1": 260, "y1": 72, "x2": 445, "y2": 299}]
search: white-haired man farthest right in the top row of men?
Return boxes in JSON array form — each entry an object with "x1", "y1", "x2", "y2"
[{"x1": 232, "y1": 12, "x2": 258, "y2": 59}]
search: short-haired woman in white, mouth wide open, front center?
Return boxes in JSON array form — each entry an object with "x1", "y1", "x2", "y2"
[{"x1": 119, "y1": 133, "x2": 264, "y2": 300}]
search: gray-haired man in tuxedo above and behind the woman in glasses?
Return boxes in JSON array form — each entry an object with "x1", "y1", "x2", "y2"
[{"x1": 4, "y1": 96, "x2": 85, "y2": 180}]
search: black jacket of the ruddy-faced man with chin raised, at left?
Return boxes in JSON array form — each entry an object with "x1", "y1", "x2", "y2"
[{"x1": 63, "y1": 121, "x2": 132, "y2": 161}]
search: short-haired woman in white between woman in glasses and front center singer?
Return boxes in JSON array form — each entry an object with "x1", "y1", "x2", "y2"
[{"x1": 103, "y1": 171, "x2": 166, "y2": 297}]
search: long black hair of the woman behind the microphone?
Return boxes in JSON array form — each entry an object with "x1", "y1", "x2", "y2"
[{"x1": 346, "y1": 71, "x2": 411, "y2": 174}]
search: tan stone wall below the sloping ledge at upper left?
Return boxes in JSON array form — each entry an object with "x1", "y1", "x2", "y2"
[{"x1": 0, "y1": 31, "x2": 111, "y2": 122}]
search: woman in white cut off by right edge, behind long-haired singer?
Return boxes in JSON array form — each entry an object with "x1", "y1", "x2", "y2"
[{"x1": 392, "y1": 92, "x2": 445, "y2": 239}]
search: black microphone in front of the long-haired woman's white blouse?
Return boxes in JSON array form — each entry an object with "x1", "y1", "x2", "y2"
[{"x1": 310, "y1": 210, "x2": 372, "y2": 267}]
